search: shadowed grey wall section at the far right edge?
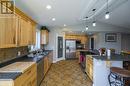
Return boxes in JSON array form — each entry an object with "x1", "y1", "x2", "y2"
[{"x1": 121, "y1": 34, "x2": 130, "y2": 51}]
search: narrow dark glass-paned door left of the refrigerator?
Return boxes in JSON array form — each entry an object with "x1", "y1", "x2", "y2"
[{"x1": 58, "y1": 36, "x2": 63, "y2": 58}]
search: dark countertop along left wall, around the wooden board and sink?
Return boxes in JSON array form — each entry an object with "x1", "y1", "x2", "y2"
[{"x1": 0, "y1": 50, "x2": 52, "y2": 80}]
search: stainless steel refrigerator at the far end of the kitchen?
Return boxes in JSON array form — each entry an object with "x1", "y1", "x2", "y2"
[{"x1": 65, "y1": 40, "x2": 76, "y2": 59}]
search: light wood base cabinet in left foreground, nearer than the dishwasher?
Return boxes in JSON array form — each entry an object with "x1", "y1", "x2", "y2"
[{"x1": 0, "y1": 64, "x2": 37, "y2": 86}]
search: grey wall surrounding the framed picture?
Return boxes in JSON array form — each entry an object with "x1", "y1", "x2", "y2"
[{"x1": 93, "y1": 32, "x2": 121, "y2": 53}]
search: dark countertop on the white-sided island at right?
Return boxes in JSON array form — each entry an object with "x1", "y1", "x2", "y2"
[{"x1": 92, "y1": 54, "x2": 130, "y2": 61}]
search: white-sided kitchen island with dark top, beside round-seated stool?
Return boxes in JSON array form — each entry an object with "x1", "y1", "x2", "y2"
[{"x1": 86, "y1": 54, "x2": 130, "y2": 86}]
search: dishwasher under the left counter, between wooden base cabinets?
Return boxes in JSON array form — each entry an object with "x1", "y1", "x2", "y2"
[{"x1": 37, "y1": 59, "x2": 44, "y2": 86}]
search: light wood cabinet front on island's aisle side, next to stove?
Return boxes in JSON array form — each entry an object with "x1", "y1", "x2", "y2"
[{"x1": 86, "y1": 56, "x2": 93, "y2": 80}]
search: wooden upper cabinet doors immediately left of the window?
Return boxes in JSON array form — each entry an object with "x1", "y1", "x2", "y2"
[{"x1": 18, "y1": 17, "x2": 36, "y2": 46}]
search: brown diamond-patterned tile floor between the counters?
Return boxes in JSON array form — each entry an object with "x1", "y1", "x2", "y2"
[{"x1": 41, "y1": 60, "x2": 92, "y2": 86}]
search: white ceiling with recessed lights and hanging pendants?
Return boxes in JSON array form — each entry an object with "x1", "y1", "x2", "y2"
[{"x1": 16, "y1": 0, "x2": 130, "y2": 28}]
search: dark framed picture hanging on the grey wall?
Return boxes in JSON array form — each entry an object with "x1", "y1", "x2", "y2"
[{"x1": 105, "y1": 33, "x2": 117, "y2": 42}]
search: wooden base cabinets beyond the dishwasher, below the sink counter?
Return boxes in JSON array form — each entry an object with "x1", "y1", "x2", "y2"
[{"x1": 44, "y1": 52, "x2": 53, "y2": 76}]
